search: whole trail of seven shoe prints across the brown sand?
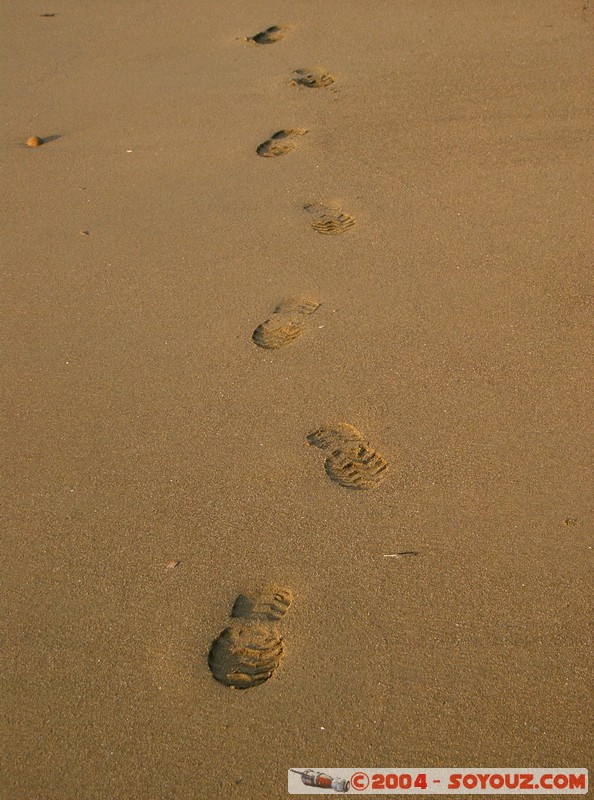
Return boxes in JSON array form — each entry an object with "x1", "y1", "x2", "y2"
[{"x1": 208, "y1": 25, "x2": 388, "y2": 689}]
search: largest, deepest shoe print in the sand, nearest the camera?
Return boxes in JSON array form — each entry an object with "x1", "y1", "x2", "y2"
[{"x1": 208, "y1": 586, "x2": 293, "y2": 689}]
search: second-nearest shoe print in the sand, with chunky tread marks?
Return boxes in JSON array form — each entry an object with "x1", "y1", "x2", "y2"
[{"x1": 307, "y1": 422, "x2": 388, "y2": 489}]
